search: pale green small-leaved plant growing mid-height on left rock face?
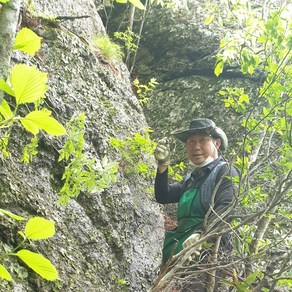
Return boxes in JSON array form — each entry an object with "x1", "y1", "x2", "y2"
[{"x1": 58, "y1": 114, "x2": 118, "y2": 205}]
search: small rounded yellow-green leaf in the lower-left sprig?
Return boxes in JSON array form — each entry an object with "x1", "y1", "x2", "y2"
[{"x1": 24, "y1": 217, "x2": 55, "y2": 240}]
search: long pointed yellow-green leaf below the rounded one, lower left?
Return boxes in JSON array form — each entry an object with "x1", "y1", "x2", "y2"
[{"x1": 16, "y1": 249, "x2": 59, "y2": 281}]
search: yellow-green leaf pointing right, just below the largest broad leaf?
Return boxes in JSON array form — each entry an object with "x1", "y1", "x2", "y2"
[{"x1": 20, "y1": 109, "x2": 66, "y2": 136}]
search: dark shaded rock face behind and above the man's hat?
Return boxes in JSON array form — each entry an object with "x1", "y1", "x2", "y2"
[{"x1": 103, "y1": 0, "x2": 259, "y2": 162}]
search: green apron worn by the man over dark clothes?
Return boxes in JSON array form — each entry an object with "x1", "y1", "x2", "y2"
[{"x1": 162, "y1": 189, "x2": 205, "y2": 265}]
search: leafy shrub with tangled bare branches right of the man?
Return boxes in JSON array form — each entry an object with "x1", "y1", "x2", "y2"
[{"x1": 152, "y1": 0, "x2": 292, "y2": 292}]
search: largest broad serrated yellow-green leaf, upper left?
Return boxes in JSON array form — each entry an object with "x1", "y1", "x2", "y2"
[{"x1": 11, "y1": 64, "x2": 48, "y2": 105}]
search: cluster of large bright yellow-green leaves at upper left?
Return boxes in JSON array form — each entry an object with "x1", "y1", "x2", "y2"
[{"x1": 0, "y1": 28, "x2": 66, "y2": 162}]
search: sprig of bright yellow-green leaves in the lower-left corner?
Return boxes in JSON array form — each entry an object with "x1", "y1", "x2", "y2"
[{"x1": 0, "y1": 209, "x2": 59, "y2": 281}]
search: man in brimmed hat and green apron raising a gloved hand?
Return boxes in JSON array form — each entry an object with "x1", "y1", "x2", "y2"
[{"x1": 154, "y1": 118, "x2": 238, "y2": 291}]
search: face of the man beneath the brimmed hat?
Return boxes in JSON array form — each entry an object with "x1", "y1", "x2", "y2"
[{"x1": 186, "y1": 134, "x2": 221, "y2": 165}]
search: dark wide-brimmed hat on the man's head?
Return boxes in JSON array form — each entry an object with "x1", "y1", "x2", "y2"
[{"x1": 171, "y1": 118, "x2": 228, "y2": 152}]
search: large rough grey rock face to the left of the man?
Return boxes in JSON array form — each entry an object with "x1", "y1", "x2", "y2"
[{"x1": 0, "y1": 0, "x2": 163, "y2": 292}]
